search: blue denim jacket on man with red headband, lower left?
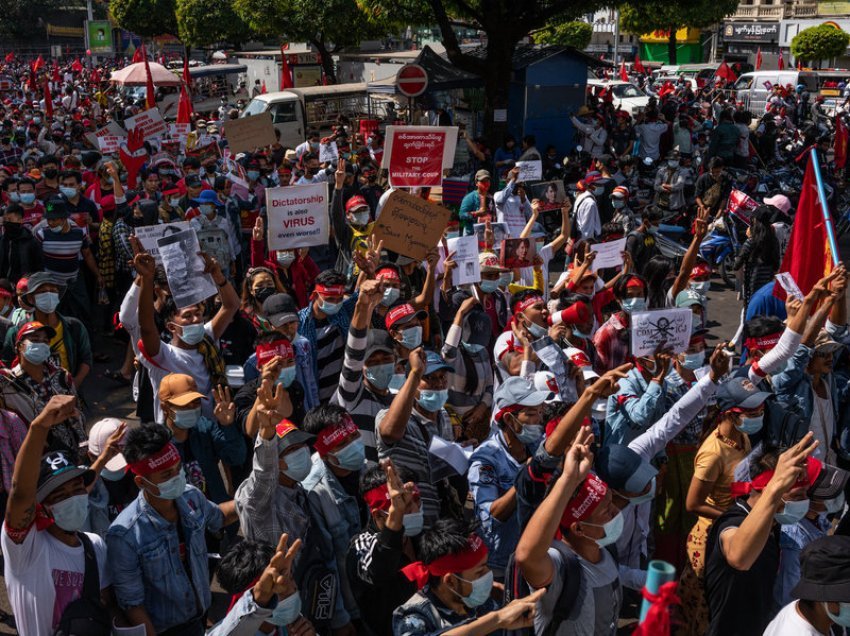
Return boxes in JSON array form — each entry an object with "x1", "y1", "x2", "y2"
[{"x1": 106, "y1": 486, "x2": 224, "y2": 632}]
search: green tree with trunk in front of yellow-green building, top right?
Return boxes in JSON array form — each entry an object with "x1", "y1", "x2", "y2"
[{"x1": 620, "y1": 0, "x2": 738, "y2": 64}]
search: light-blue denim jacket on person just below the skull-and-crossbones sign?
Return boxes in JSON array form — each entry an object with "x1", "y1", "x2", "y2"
[{"x1": 604, "y1": 369, "x2": 667, "y2": 446}]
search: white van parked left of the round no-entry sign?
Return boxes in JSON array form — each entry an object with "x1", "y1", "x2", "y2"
[{"x1": 242, "y1": 83, "x2": 371, "y2": 148}]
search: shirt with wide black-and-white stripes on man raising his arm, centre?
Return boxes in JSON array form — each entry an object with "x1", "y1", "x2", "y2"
[{"x1": 331, "y1": 327, "x2": 393, "y2": 462}]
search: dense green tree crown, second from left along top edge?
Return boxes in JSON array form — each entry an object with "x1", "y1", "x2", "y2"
[{"x1": 176, "y1": 0, "x2": 252, "y2": 46}]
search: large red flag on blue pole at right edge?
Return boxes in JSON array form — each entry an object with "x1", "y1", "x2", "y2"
[{"x1": 773, "y1": 149, "x2": 832, "y2": 298}]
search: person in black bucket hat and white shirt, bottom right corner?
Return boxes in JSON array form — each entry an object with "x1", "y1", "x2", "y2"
[{"x1": 764, "y1": 535, "x2": 850, "y2": 636}]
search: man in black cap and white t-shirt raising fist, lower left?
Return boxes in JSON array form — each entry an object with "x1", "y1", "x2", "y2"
[{"x1": 0, "y1": 395, "x2": 112, "y2": 636}]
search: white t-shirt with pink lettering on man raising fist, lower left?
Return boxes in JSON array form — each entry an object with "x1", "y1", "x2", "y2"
[{"x1": 0, "y1": 524, "x2": 111, "y2": 636}]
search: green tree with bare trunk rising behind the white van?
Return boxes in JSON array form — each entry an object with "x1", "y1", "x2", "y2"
[{"x1": 233, "y1": 0, "x2": 397, "y2": 82}]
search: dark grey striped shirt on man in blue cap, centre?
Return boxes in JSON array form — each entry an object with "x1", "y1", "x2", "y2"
[{"x1": 375, "y1": 407, "x2": 454, "y2": 528}]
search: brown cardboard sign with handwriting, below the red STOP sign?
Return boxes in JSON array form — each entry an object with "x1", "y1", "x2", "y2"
[{"x1": 372, "y1": 190, "x2": 452, "y2": 261}]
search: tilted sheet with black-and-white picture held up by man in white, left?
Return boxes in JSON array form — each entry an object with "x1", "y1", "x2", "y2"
[{"x1": 156, "y1": 228, "x2": 218, "y2": 309}]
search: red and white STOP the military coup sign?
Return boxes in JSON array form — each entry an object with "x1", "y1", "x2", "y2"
[{"x1": 381, "y1": 126, "x2": 457, "y2": 188}]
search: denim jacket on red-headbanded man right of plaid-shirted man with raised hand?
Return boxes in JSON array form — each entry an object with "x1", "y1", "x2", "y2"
[{"x1": 301, "y1": 455, "x2": 363, "y2": 629}]
